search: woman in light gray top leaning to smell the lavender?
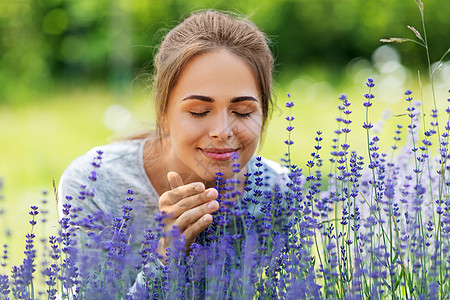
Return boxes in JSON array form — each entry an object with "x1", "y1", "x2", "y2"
[{"x1": 59, "y1": 11, "x2": 287, "y2": 266}]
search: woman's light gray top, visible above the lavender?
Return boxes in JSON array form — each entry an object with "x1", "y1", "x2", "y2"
[{"x1": 58, "y1": 139, "x2": 289, "y2": 234}]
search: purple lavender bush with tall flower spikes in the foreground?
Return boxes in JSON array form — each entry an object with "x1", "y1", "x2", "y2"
[{"x1": 0, "y1": 0, "x2": 450, "y2": 299}]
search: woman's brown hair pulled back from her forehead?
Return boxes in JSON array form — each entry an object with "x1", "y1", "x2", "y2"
[{"x1": 153, "y1": 10, "x2": 273, "y2": 136}]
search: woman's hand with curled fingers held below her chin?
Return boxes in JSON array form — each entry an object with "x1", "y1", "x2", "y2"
[{"x1": 158, "y1": 172, "x2": 219, "y2": 257}]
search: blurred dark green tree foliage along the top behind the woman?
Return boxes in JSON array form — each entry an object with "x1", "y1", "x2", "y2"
[{"x1": 0, "y1": 0, "x2": 450, "y2": 102}]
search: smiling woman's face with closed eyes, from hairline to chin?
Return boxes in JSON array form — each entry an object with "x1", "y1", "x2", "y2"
[{"x1": 161, "y1": 50, "x2": 262, "y2": 182}]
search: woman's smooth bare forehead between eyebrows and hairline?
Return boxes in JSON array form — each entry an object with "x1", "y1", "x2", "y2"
[{"x1": 168, "y1": 49, "x2": 261, "y2": 105}]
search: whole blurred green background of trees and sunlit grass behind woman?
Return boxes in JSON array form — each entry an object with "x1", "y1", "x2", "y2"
[{"x1": 0, "y1": 0, "x2": 450, "y2": 278}]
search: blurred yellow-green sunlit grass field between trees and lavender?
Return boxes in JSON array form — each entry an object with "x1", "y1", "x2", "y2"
[{"x1": 0, "y1": 55, "x2": 448, "y2": 276}]
